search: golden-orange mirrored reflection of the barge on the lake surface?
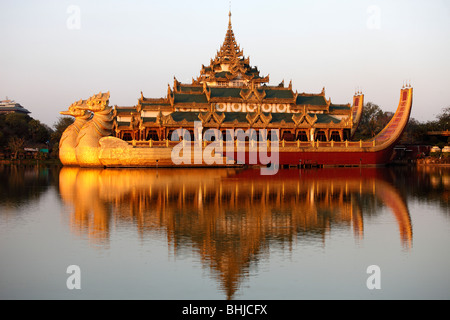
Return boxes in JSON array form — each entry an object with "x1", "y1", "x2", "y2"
[{"x1": 59, "y1": 167, "x2": 413, "y2": 298}]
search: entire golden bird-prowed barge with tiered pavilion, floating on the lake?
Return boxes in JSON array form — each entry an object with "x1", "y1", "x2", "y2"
[{"x1": 60, "y1": 13, "x2": 412, "y2": 167}]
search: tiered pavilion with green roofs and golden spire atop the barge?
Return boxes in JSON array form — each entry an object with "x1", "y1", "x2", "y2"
[{"x1": 114, "y1": 12, "x2": 363, "y2": 141}]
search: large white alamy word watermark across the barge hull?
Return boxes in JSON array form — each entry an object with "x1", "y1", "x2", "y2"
[{"x1": 170, "y1": 121, "x2": 279, "y2": 175}]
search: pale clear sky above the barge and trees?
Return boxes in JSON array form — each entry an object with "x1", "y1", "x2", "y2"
[{"x1": 0, "y1": 0, "x2": 450, "y2": 126}]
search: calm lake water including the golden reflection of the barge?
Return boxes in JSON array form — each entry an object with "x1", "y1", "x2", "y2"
[{"x1": 0, "y1": 166, "x2": 450, "y2": 300}]
